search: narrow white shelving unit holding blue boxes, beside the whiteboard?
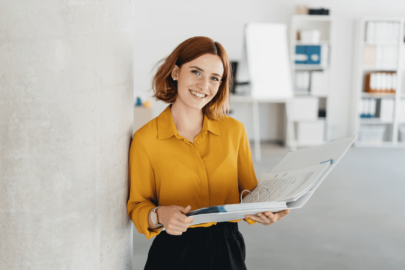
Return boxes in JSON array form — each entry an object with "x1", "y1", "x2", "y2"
[{"x1": 290, "y1": 15, "x2": 334, "y2": 147}]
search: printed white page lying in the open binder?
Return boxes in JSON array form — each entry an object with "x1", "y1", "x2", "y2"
[{"x1": 242, "y1": 162, "x2": 331, "y2": 203}]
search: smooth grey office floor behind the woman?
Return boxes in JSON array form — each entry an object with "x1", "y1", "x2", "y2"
[{"x1": 134, "y1": 144, "x2": 405, "y2": 270}]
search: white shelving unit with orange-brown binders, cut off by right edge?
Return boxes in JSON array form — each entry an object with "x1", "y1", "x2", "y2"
[{"x1": 352, "y1": 17, "x2": 405, "y2": 147}]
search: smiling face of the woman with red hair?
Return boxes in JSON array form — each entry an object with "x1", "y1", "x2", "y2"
[{"x1": 172, "y1": 54, "x2": 224, "y2": 110}]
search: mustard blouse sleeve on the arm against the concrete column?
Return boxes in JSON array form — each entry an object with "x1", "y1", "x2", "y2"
[{"x1": 127, "y1": 132, "x2": 160, "y2": 239}]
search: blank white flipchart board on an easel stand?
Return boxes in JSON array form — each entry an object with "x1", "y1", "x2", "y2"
[{"x1": 244, "y1": 23, "x2": 293, "y2": 99}]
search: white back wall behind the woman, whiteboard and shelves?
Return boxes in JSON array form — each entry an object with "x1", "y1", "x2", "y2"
[{"x1": 135, "y1": 0, "x2": 405, "y2": 140}]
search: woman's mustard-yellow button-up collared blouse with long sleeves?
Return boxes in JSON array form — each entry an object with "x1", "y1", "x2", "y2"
[{"x1": 127, "y1": 106, "x2": 257, "y2": 239}]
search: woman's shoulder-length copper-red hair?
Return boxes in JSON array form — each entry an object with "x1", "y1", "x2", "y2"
[{"x1": 152, "y1": 37, "x2": 232, "y2": 120}]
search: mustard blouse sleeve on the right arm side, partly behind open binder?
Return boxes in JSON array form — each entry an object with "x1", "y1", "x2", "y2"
[{"x1": 238, "y1": 127, "x2": 257, "y2": 225}]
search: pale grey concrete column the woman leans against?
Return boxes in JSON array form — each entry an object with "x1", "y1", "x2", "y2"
[{"x1": 0, "y1": 0, "x2": 134, "y2": 270}]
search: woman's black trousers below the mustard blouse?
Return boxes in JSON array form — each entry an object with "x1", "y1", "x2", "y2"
[{"x1": 145, "y1": 222, "x2": 246, "y2": 270}]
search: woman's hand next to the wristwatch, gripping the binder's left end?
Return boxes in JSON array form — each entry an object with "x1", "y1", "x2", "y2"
[{"x1": 157, "y1": 205, "x2": 194, "y2": 235}]
